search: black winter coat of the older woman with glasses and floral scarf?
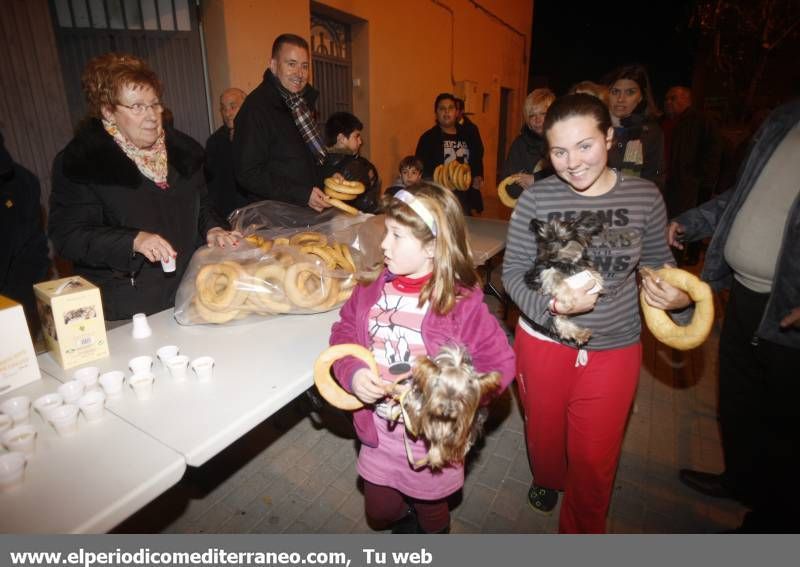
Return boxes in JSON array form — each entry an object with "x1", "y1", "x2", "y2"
[{"x1": 48, "y1": 119, "x2": 223, "y2": 321}]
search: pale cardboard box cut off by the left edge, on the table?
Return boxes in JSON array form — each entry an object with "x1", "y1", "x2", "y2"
[{"x1": 0, "y1": 295, "x2": 42, "y2": 394}]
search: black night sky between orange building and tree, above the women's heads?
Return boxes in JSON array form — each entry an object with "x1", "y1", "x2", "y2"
[{"x1": 529, "y1": 0, "x2": 695, "y2": 107}]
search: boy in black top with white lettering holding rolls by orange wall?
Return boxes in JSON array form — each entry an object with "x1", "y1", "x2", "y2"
[{"x1": 415, "y1": 93, "x2": 483, "y2": 215}]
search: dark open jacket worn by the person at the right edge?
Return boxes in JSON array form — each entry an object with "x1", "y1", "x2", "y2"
[{"x1": 675, "y1": 100, "x2": 800, "y2": 349}]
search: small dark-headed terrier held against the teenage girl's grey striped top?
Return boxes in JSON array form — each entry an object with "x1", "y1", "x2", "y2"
[{"x1": 525, "y1": 213, "x2": 603, "y2": 346}]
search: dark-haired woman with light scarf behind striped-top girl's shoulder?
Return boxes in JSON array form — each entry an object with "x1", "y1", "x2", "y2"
[{"x1": 606, "y1": 65, "x2": 665, "y2": 191}]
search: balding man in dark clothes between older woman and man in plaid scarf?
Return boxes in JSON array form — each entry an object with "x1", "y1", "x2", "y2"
[{"x1": 205, "y1": 88, "x2": 247, "y2": 218}]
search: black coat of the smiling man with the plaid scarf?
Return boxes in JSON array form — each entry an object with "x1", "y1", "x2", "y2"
[{"x1": 233, "y1": 69, "x2": 322, "y2": 206}]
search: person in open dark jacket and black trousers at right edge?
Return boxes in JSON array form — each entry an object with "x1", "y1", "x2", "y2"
[{"x1": 669, "y1": 100, "x2": 800, "y2": 533}]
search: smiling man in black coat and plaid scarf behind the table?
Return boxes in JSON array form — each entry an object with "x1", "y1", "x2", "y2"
[{"x1": 233, "y1": 34, "x2": 330, "y2": 211}]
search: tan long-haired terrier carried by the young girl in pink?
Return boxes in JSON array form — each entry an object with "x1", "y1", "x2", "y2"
[{"x1": 393, "y1": 346, "x2": 500, "y2": 470}]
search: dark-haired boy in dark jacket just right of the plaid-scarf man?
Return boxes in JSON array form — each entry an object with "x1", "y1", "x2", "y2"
[{"x1": 322, "y1": 112, "x2": 381, "y2": 213}]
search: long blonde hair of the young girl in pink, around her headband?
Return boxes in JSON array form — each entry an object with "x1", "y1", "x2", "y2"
[{"x1": 381, "y1": 183, "x2": 480, "y2": 315}]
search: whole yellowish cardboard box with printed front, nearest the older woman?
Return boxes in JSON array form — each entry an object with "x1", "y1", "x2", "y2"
[{"x1": 33, "y1": 276, "x2": 108, "y2": 369}]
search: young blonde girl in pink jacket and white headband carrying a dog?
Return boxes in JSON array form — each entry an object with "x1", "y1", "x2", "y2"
[{"x1": 330, "y1": 183, "x2": 515, "y2": 533}]
